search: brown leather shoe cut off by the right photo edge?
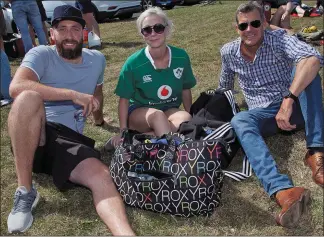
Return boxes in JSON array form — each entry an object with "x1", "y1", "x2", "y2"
[{"x1": 304, "y1": 150, "x2": 324, "y2": 187}]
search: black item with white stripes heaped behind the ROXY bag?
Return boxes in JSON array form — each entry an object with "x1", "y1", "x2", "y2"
[{"x1": 179, "y1": 89, "x2": 240, "y2": 169}]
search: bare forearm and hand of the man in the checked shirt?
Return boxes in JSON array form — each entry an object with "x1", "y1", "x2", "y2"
[{"x1": 276, "y1": 57, "x2": 320, "y2": 131}]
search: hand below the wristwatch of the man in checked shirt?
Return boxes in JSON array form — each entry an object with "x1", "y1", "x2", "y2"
[{"x1": 276, "y1": 98, "x2": 296, "y2": 131}]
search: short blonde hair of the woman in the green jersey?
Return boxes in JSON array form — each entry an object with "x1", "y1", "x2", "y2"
[{"x1": 136, "y1": 7, "x2": 173, "y2": 37}]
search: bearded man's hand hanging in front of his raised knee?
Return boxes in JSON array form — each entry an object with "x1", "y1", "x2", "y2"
[{"x1": 72, "y1": 91, "x2": 99, "y2": 117}]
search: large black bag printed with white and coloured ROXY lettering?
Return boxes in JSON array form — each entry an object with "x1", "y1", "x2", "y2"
[{"x1": 110, "y1": 131, "x2": 224, "y2": 217}]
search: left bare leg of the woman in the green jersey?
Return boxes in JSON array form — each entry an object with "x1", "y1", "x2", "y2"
[{"x1": 129, "y1": 108, "x2": 171, "y2": 136}]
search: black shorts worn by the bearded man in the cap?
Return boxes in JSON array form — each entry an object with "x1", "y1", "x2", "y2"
[{"x1": 33, "y1": 122, "x2": 100, "y2": 191}]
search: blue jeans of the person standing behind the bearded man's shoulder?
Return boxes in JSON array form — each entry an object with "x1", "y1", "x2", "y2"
[{"x1": 11, "y1": 0, "x2": 47, "y2": 53}]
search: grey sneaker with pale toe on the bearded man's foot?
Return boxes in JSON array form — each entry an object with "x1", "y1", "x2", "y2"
[{"x1": 8, "y1": 186, "x2": 39, "y2": 233}]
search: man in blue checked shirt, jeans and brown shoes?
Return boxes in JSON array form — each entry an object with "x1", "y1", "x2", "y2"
[{"x1": 219, "y1": 2, "x2": 324, "y2": 227}]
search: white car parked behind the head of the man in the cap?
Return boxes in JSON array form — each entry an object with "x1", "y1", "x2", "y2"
[{"x1": 43, "y1": 0, "x2": 142, "y2": 22}]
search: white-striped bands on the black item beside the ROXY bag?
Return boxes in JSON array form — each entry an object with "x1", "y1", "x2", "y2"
[{"x1": 209, "y1": 90, "x2": 252, "y2": 181}]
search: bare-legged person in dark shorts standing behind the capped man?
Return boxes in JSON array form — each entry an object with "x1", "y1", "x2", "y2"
[{"x1": 75, "y1": 0, "x2": 100, "y2": 38}]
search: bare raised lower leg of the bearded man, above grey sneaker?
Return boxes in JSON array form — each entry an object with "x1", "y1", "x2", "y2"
[{"x1": 8, "y1": 91, "x2": 45, "y2": 190}]
